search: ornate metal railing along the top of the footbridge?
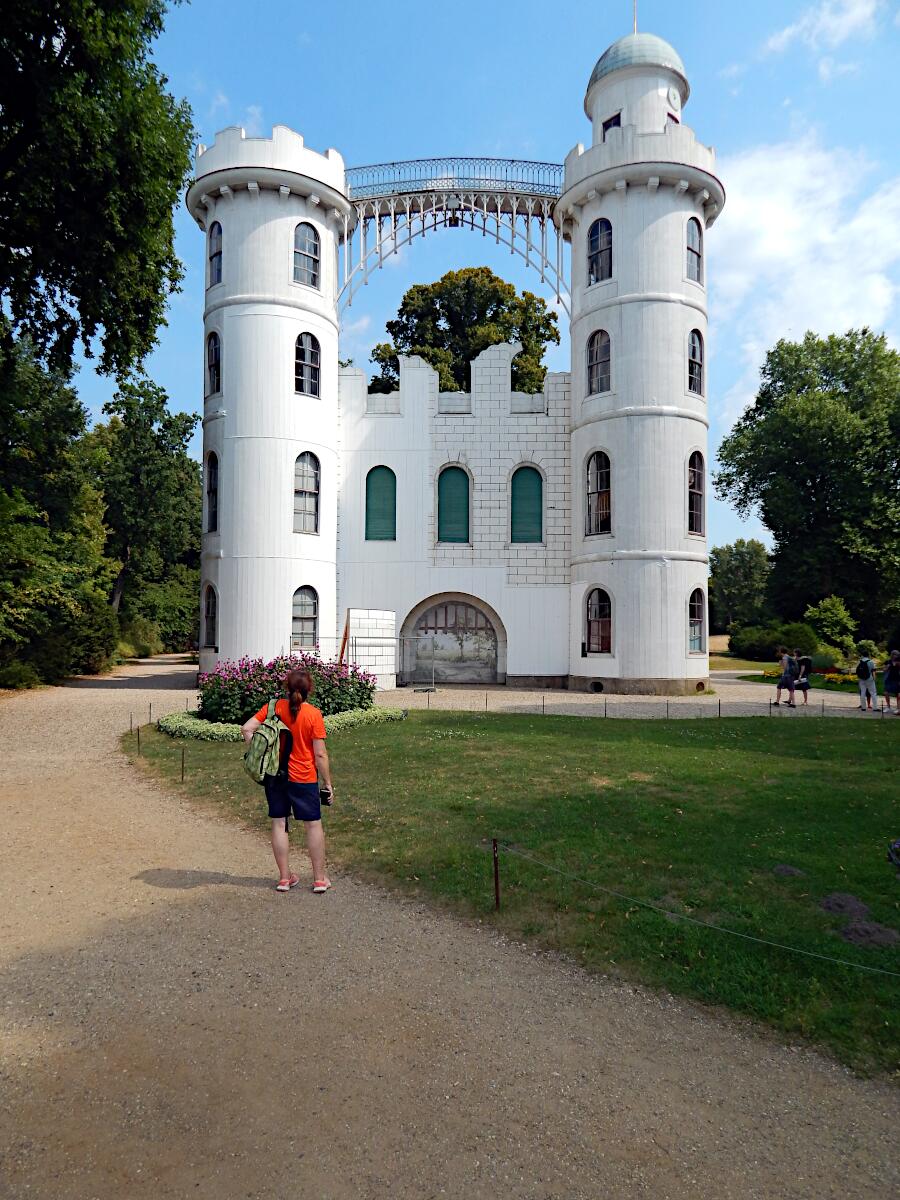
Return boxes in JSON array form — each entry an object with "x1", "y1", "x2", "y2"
[{"x1": 347, "y1": 158, "x2": 563, "y2": 200}]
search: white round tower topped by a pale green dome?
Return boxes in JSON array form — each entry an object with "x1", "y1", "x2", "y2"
[{"x1": 564, "y1": 34, "x2": 725, "y2": 695}]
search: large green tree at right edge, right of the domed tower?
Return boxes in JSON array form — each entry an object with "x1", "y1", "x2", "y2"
[{"x1": 715, "y1": 329, "x2": 900, "y2": 636}]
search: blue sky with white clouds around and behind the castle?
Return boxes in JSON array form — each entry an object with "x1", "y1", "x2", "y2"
[{"x1": 78, "y1": 0, "x2": 900, "y2": 545}]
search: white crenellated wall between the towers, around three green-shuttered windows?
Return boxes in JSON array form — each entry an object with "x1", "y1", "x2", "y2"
[{"x1": 338, "y1": 346, "x2": 571, "y2": 678}]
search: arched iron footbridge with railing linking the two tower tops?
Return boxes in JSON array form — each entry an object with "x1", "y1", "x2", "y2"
[{"x1": 338, "y1": 158, "x2": 569, "y2": 313}]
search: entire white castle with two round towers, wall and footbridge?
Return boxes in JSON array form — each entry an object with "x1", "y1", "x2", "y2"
[{"x1": 187, "y1": 34, "x2": 725, "y2": 694}]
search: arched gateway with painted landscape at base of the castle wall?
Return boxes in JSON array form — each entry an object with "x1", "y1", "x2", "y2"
[{"x1": 400, "y1": 592, "x2": 506, "y2": 683}]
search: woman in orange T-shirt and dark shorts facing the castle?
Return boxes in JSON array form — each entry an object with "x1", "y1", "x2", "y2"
[{"x1": 241, "y1": 671, "x2": 334, "y2": 894}]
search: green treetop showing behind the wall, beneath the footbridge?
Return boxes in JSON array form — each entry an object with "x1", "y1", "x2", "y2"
[{"x1": 370, "y1": 266, "x2": 559, "y2": 392}]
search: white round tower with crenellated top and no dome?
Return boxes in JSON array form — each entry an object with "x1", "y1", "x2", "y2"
[{"x1": 187, "y1": 126, "x2": 352, "y2": 671}]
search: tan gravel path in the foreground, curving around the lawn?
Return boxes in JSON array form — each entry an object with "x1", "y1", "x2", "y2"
[{"x1": 0, "y1": 660, "x2": 900, "y2": 1200}]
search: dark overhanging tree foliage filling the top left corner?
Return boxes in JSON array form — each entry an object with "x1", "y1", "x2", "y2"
[{"x1": 0, "y1": 0, "x2": 193, "y2": 372}]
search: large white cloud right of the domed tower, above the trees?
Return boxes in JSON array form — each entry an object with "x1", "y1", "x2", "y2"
[{"x1": 710, "y1": 133, "x2": 900, "y2": 427}]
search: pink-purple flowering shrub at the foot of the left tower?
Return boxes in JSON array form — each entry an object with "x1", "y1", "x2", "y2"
[{"x1": 199, "y1": 654, "x2": 376, "y2": 725}]
